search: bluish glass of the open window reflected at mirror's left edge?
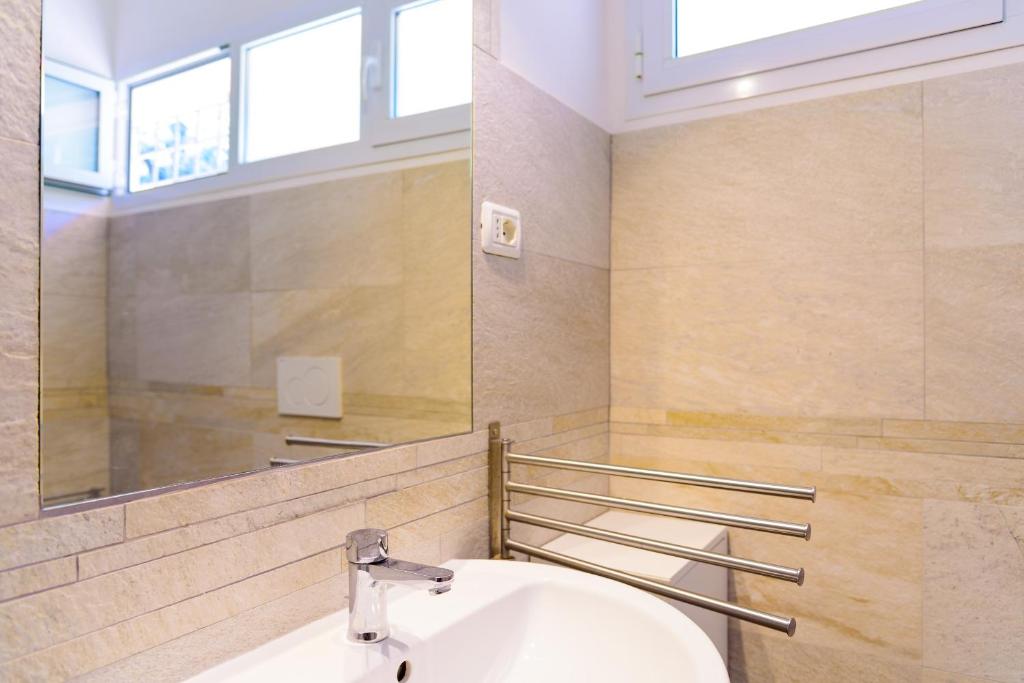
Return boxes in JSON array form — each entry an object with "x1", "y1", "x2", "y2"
[{"x1": 43, "y1": 76, "x2": 99, "y2": 175}]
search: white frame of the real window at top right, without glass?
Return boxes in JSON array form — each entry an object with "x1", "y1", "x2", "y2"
[{"x1": 634, "y1": 0, "x2": 1007, "y2": 102}]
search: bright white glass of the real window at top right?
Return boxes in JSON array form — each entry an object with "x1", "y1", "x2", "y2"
[{"x1": 675, "y1": 0, "x2": 916, "y2": 57}]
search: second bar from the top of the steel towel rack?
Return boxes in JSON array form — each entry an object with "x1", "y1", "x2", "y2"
[{"x1": 505, "y1": 481, "x2": 811, "y2": 539}]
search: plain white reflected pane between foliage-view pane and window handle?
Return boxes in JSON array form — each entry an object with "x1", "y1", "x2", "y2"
[{"x1": 243, "y1": 10, "x2": 362, "y2": 162}]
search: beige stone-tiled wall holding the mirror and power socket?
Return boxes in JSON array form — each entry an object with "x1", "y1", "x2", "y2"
[{"x1": 0, "y1": 0, "x2": 610, "y2": 683}]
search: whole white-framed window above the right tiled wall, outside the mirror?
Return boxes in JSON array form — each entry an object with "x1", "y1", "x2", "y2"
[{"x1": 637, "y1": 0, "x2": 1004, "y2": 99}]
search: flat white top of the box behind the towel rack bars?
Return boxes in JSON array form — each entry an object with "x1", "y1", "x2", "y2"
[{"x1": 544, "y1": 510, "x2": 728, "y2": 584}]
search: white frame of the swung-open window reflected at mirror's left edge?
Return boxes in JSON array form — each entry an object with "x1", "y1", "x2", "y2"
[{"x1": 42, "y1": 59, "x2": 117, "y2": 194}]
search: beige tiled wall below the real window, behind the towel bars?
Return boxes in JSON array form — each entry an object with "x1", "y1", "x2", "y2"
[{"x1": 610, "y1": 65, "x2": 1024, "y2": 683}]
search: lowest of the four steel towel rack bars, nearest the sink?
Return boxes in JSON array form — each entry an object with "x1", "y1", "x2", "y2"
[{"x1": 505, "y1": 539, "x2": 797, "y2": 636}]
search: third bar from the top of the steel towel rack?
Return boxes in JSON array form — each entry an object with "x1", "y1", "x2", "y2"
[{"x1": 505, "y1": 510, "x2": 804, "y2": 586}]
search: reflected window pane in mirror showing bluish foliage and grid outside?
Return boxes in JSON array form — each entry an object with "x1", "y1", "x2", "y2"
[{"x1": 128, "y1": 56, "x2": 231, "y2": 193}]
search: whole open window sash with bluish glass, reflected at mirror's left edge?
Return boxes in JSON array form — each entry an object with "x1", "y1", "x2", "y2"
[{"x1": 42, "y1": 60, "x2": 114, "y2": 190}]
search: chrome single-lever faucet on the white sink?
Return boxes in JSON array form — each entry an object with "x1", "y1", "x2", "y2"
[{"x1": 345, "y1": 528, "x2": 455, "y2": 643}]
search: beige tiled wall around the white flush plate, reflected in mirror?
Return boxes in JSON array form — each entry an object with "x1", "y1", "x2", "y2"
[{"x1": 103, "y1": 161, "x2": 472, "y2": 493}]
